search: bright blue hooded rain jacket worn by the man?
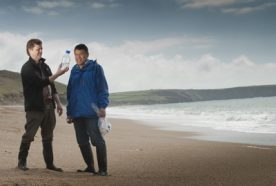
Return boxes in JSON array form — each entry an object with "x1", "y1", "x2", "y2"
[{"x1": 67, "y1": 60, "x2": 109, "y2": 118}]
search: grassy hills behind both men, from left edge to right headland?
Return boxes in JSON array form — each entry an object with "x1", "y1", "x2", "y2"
[{"x1": 0, "y1": 70, "x2": 276, "y2": 106}]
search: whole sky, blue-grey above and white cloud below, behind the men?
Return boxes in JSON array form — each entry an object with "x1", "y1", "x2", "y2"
[{"x1": 0, "y1": 0, "x2": 276, "y2": 92}]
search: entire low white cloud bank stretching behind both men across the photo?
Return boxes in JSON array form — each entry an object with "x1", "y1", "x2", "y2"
[{"x1": 0, "y1": 32, "x2": 276, "y2": 92}]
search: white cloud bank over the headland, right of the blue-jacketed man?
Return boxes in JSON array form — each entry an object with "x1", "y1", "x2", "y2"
[{"x1": 85, "y1": 39, "x2": 276, "y2": 92}]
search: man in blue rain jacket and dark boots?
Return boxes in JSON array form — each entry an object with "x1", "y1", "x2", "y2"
[{"x1": 67, "y1": 44, "x2": 109, "y2": 176}]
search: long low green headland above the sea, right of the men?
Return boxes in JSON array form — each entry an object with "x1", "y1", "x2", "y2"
[{"x1": 108, "y1": 85, "x2": 276, "y2": 105}]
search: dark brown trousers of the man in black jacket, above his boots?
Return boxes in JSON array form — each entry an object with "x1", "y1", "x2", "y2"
[{"x1": 22, "y1": 103, "x2": 56, "y2": 143}]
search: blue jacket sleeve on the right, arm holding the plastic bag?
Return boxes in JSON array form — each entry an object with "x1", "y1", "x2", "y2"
[{"x1": 96, "y1": 65, "x2": 109, "y2": 108}]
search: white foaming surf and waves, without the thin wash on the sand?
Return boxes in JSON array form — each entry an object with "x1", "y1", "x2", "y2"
[{"x1": 108, "y1": 97, "x2": 276, "y2": 134}]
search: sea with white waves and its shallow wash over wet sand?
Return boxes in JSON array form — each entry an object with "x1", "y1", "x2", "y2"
[{"x1": 108, "y1": 97, "x2": 276, "y2": 146}]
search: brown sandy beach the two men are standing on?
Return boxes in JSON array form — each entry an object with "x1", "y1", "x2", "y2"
[{"x1": 0, "y1": 107, "x2": 276, "y2": 186}]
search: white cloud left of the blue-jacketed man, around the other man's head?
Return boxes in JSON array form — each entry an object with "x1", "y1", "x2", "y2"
[{"x1": 0, "y1": 32, "x2": 75, "y2": 83}]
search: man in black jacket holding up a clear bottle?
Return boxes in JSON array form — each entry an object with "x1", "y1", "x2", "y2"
[{"x1": 18, "y1": 39, "x2": 68, "y2": 172}]
